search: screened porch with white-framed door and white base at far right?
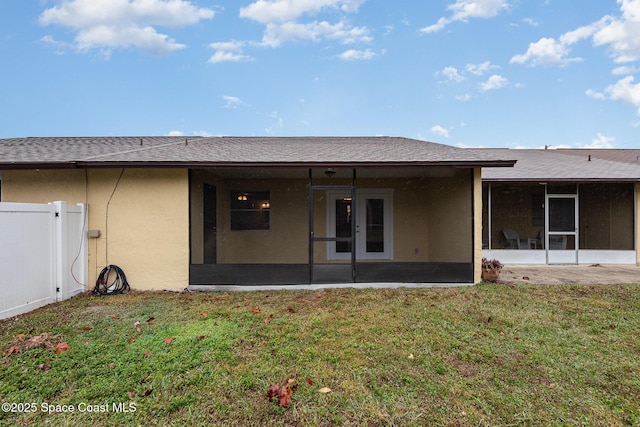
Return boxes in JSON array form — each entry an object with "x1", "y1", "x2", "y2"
[{"x1": 482, "y1": 182, "x2": 636, "y2": 264}]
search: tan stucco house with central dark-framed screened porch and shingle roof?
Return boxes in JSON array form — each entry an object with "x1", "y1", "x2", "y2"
[{"x1": 0, "y1": 137, "x2": 514, "y2": 290}]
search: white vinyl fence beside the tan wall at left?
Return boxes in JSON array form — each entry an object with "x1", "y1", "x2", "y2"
[{"x1": 0, "y1": 202, "x2": 87, "y2": 319}]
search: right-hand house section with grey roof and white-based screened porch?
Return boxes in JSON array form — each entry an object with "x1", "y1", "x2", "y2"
[{"x1": 482, "y1": 149, "x2": 640, "y2": 264}]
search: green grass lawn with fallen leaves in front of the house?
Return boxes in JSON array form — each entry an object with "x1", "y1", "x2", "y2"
[{"x1": 0, "y1": 284, "x2": 640, "y2": 427}]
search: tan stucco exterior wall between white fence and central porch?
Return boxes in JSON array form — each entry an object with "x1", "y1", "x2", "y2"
[{"x1": 2, "y1": 169, "x2": 189, "y2": 290}]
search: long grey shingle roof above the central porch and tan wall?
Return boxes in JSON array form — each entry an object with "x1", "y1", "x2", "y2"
[{"x1": 0, "y1": 137, "x2": 513, "y2": 168}]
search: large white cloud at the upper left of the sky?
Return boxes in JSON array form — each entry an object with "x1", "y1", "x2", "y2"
[{"x1": 39, "y1": 0, "x2": 215, "y2": 54}]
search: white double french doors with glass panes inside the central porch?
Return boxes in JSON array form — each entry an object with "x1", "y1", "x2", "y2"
[{"x1": 327, "y1": 189, "x2": 393, "y2": 260}]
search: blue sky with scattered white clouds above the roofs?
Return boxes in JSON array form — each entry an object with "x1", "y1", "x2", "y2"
[{"x1": 0, "y1": 0, "x2": 640, "y2": 148}]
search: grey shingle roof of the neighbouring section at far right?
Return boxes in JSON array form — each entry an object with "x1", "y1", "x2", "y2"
[{"x1": 482, "y1": 148, "x2": 640, "y2": 182}]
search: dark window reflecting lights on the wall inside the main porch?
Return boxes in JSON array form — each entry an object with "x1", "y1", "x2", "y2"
[{"x1": 230, "y1": 191, "x2": 271, "y2": 230}]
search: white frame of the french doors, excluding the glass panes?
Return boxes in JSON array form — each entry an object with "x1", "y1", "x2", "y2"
[{"x1": 325, "y1": 188, "x2": 393, "y2": 261}]
